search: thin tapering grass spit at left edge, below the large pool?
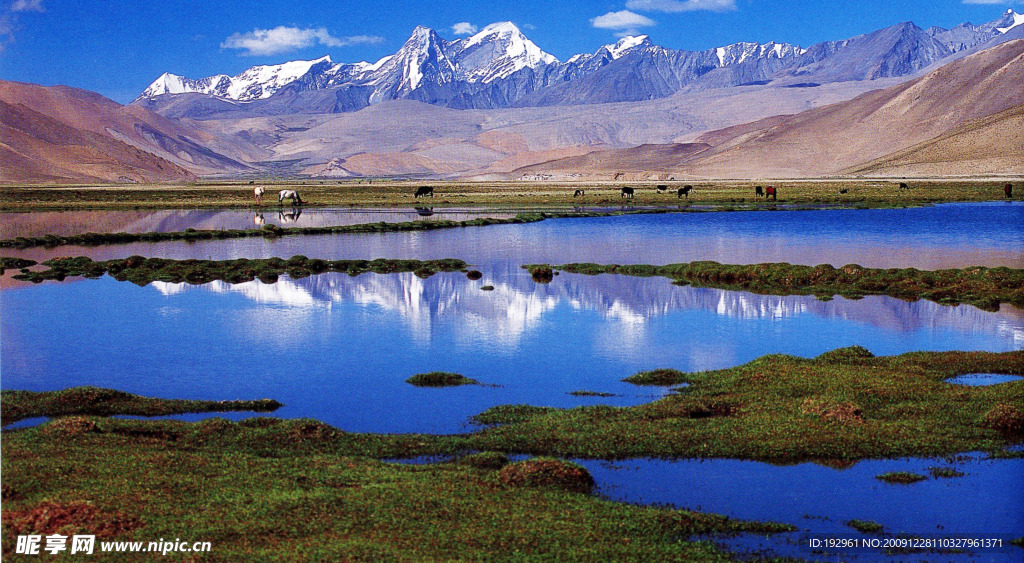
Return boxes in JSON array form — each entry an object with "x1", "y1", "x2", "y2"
[{"x1": 0, "y1": 387, "x2": 282, "y2": 426}]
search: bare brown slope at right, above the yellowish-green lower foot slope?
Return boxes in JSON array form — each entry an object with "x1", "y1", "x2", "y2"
[{"x1": 685, "y1": 41, "x2": 1024, "y2": 176}]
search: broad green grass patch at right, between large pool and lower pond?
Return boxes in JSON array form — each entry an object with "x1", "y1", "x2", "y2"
[{"x1": 469, "y1": 349, "x2": 1024, "y2": 463}]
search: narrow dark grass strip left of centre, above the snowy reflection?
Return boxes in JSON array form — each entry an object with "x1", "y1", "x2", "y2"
[{"x1": 8, "y1": 255, "x2": 466, "y2": 286}]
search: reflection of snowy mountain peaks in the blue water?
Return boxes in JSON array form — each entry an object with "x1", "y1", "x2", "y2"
[{"x1": 153, "y1": 267, "x2": 1024, "y2": 347}]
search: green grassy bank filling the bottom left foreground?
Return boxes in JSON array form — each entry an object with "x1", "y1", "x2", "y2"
[{"x1": 0, "y1": 425, "x2": 795, "y2": 561}]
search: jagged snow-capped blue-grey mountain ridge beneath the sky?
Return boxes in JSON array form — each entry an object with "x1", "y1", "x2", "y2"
[{"x1": 136, "y1": 9, "x2": 1024, "y2": 117}]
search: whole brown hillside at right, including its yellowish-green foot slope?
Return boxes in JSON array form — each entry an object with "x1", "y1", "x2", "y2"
[{"x1": 517, "y1": 40, "x2": 1024, "y2": 177}]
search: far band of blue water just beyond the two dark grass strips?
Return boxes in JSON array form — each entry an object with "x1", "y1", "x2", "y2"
[{"x1": 5, "y1": 202, "x2": 1024, "y2": 269}]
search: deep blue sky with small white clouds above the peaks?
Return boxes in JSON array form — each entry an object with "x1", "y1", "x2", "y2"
[{"x1": 0, "y1": 0, "x2": 1024, "y2": 103}]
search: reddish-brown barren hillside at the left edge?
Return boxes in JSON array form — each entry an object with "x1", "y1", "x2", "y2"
[{"x1": 0, "y1": 81, "x2": 259, "y2": 182}]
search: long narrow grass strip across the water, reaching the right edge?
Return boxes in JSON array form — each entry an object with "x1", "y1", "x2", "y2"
[{"x1": 536, "y1": 261, "x2": 1024, "y2": 311}]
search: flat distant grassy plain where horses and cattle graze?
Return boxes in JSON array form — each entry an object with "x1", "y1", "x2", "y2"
[{"x1": 0, "y1": 178, "x2": 1024, "y2": 211}]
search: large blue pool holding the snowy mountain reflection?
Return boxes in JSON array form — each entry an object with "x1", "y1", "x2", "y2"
[{"x1": 0, "y1": 266, "x2": 1024, "y2": 433}]
